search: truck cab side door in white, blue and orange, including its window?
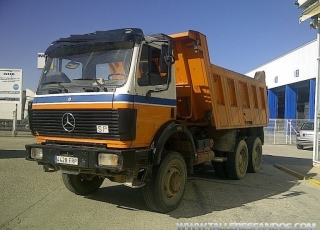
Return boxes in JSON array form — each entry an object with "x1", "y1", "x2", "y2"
[{"x1": 134, "y1": 43, "x2": 176, "y2": 146}]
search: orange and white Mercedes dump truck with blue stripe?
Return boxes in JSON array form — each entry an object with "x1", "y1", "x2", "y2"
[{"x1": 26, "y1": 28, "x2": 268, "y2": 213}]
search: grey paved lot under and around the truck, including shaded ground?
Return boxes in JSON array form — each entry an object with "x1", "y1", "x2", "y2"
[{"x1": 0, "y1": 137, "x2": 320, "y2": 229}]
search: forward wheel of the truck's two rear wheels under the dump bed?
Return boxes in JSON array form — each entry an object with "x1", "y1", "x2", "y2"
[{"x1": 227, "y1": 140, "x2": 248, "y2": 180}]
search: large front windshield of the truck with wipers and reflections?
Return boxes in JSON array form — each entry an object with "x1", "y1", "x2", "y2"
[{"x1": 37, "y1": 42, "x2": 133, "y2": 94}]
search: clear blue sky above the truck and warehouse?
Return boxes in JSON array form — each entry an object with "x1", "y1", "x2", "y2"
[{"x1": 0, "y1": 0, "x2": 317, "y2": 90}]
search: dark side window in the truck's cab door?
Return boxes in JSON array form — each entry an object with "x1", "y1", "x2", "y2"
[{"x1": 138, "y1": 45, "x2": 167, "y2": 86}]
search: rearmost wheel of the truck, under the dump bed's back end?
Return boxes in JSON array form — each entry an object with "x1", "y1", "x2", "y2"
[{"x1": 246, "y1": 136, "x2": 262, "y2": 173}]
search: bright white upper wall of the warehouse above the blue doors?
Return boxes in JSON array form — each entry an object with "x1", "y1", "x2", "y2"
[{"x1": 245, "y1": 40, "x2": 318, "y2": 89}]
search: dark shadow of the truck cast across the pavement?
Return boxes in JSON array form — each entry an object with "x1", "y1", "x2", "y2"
[{"x1": 87, "y1": 155, "x2": 312, "y2": 219}]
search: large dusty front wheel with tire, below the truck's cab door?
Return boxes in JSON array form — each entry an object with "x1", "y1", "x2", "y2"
[{"x1": 143, "y1": 152, "x2": 187, "y2": 213}]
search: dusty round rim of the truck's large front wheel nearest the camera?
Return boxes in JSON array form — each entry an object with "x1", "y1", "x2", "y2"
[{"x1": 164, "y1": 166, "x2": 182, "y2": 198}]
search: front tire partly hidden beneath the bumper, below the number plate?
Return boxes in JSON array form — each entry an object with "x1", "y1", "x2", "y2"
[{"x1": 62, "y1": 173, "x2": 104, "y2": 196}]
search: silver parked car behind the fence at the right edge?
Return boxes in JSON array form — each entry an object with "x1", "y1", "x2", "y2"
[{"x1": 296, "y1": 122, "x2": 314, "y2": 149}]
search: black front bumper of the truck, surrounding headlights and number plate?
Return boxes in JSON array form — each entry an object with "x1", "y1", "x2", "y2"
[{"x1": 25, "y1": 144, "x2": 151, "y2": 171}]
